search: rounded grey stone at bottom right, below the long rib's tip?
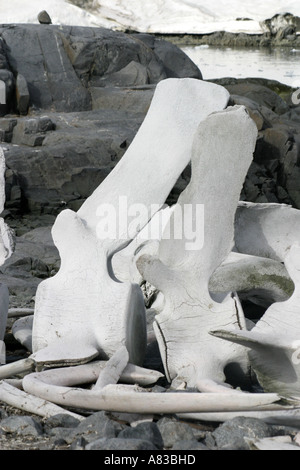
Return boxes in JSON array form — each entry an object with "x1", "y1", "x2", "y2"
[{"x1": 212, "y1": 417, "x2": 273, "y2": 450}]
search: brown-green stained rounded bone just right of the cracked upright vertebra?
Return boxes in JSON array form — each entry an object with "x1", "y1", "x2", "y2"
[{"x1": 209, "y1": 252, "x2": 294, "y2": 307}]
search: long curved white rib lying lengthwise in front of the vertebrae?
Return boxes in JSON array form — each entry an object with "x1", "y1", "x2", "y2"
[{"x1": 23, "y1": 369, "x2": 280, "y2": 413}]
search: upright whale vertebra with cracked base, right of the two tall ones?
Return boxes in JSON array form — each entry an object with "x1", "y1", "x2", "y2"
[{"x1": 137, "y1": 106, "x2": 257, "y2": 391}]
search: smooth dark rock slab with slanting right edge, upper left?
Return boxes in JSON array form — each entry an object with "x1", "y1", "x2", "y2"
[{"x1": 0, "y1": 25, "x2": 90, "y2": 111}]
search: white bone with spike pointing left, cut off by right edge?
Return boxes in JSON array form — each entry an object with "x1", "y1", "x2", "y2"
[{"x1": 213, "y1": 243, "x2": 300, "y2": 399}]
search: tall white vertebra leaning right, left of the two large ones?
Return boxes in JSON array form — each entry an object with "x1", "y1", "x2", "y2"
[{"x1": 32, "y1": 78, "x2": 229, "y2": 365}]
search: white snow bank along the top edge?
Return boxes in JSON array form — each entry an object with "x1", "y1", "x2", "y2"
[{"x1": 0, "y1": 0, "x2": 300, "y2": 34}]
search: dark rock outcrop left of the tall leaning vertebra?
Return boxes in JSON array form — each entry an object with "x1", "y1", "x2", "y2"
[{"x1": 0, "y1": 24, "x2": 202, "y2": 214}]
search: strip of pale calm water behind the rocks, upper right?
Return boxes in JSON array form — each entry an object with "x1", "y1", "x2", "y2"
[{"x1": 181, "y1": 45, "x2": 300, "y2": 88}]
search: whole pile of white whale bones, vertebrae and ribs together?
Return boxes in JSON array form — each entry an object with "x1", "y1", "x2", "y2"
[{"x1": 0, "y1": 78, "x2": 300, "y2": 425}]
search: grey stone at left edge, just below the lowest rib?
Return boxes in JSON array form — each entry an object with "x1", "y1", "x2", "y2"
[{"x1": 0, "y1": 416, "x2": 43, "y2": 437}]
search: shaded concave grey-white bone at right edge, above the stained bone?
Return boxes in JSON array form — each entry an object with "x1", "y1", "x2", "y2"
[{"x1": 235, "y1": 202, "x2": 300, "y2": 261}]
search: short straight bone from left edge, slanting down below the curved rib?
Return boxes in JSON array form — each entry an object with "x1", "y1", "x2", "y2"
[{"x1": 0, "y1": 381, "x2": 84, "y2": 420}]
